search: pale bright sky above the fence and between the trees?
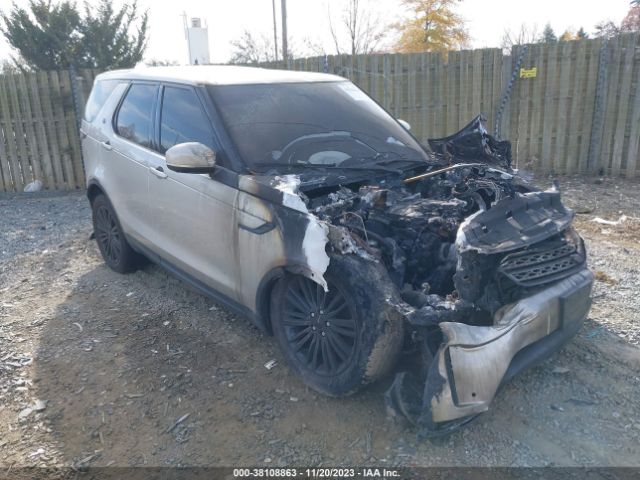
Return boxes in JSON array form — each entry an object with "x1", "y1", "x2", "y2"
[{"x1": 0, "y1": 0, "x2": 629, "y2": 63}]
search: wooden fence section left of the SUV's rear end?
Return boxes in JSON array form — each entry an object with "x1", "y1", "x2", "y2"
[{"x1": 0, "y1": 70, "x2": 95, "y2": 191}]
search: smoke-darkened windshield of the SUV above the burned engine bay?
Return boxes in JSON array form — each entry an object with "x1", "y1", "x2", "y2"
[{"x1": 208, "y1": 81, "x2": 429, "y2": 172}]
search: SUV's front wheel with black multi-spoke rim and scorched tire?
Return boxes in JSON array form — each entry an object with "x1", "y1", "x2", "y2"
[{"x1": 271, "y1": 255, "x2": 403, "y2": 396}]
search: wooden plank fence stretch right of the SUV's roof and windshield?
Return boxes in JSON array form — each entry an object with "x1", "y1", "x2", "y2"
[{"x1": 288, "y1": 33, "x2": 640, "y2": 177}]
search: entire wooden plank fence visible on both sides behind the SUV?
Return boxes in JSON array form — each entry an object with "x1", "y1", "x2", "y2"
[{"x1": 0, "y1": 34, "x2": 640, "y2": 191}]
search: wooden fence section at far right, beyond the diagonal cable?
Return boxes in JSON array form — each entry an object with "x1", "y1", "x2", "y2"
[{"x1": 503, "y1": 34, "x2": 640, "y2": 177}]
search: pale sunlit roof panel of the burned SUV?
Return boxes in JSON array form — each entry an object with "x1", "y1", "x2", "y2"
[{"x1": 96, "y1": 65, "x2": 345, "y2": 85}]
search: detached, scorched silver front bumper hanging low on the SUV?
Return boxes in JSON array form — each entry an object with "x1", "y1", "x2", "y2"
[{"x1": 387, "y1": 268, "x2": 593, "y2": 436}]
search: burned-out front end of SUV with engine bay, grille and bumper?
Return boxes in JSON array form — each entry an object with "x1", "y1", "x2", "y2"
[{"x1": 278, "y1": 115, "x2": 592, "y2": 436}]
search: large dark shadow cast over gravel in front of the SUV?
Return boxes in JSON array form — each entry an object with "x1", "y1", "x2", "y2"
[{"x1": 28, "y1": 244, "x2": 640, "y2": 467}]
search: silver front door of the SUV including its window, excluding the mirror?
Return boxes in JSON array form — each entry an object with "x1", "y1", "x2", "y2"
[{"x1": 146, "y1": 84, "x2": 238, "y2": 300}]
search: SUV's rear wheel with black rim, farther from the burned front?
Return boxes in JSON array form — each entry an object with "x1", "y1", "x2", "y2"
[{"x1": 91, "y1": 194, "x2": 140, "y2": 273}]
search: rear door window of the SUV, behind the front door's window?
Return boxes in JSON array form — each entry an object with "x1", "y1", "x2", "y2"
[{"x1": 116, "y1": 83, "x2": 156, "y2": 147}]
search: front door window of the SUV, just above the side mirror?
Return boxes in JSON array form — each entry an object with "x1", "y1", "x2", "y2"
[{"x1": 160, "y1": 87, "x2": 215, "y2": 153}]
